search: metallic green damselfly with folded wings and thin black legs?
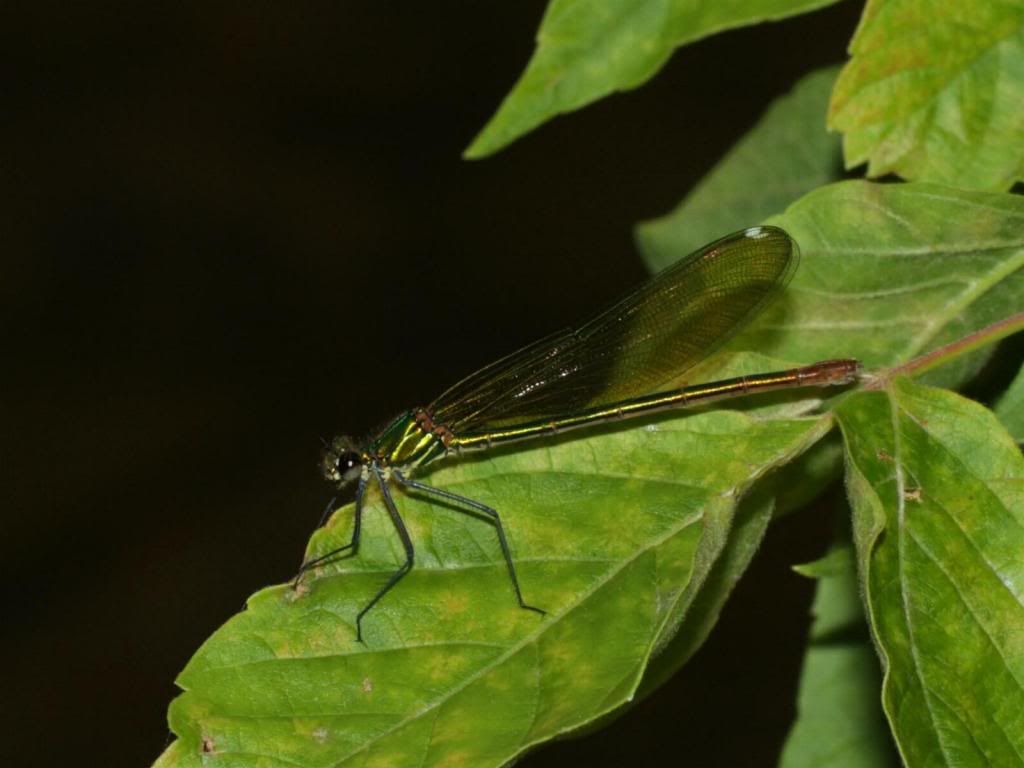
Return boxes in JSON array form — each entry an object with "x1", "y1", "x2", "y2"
[{"x1": 295, "y1": 226, "x2": 860, "y2": 641}]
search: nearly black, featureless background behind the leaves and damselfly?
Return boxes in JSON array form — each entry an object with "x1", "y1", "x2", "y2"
[{"x1": 0, "y1": 0, "x2": 859, "y2": 768}]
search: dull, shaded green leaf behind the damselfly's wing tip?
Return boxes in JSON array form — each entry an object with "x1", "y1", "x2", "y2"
[{"x1": 636, "y1": 68, "x2": 843, "y2": 271}]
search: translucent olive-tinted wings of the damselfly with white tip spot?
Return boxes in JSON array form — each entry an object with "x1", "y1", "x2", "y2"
[{"x1": 429, "y1": 226, "x2": 799, "y2": 434}]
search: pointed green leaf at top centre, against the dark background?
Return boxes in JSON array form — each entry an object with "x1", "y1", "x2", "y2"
[{"x1": 466, "y1": 0, "x2": 836, "y2": 158}]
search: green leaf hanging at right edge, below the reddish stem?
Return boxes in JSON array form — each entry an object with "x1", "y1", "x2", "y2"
[{"x1": 838, "y1": 379, "x2": 1024, "y2": 768}]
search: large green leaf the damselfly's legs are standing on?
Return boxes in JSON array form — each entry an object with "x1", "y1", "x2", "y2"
[{"x1": 157, "y1": 411, "x2": 830, "y2": 768}]
